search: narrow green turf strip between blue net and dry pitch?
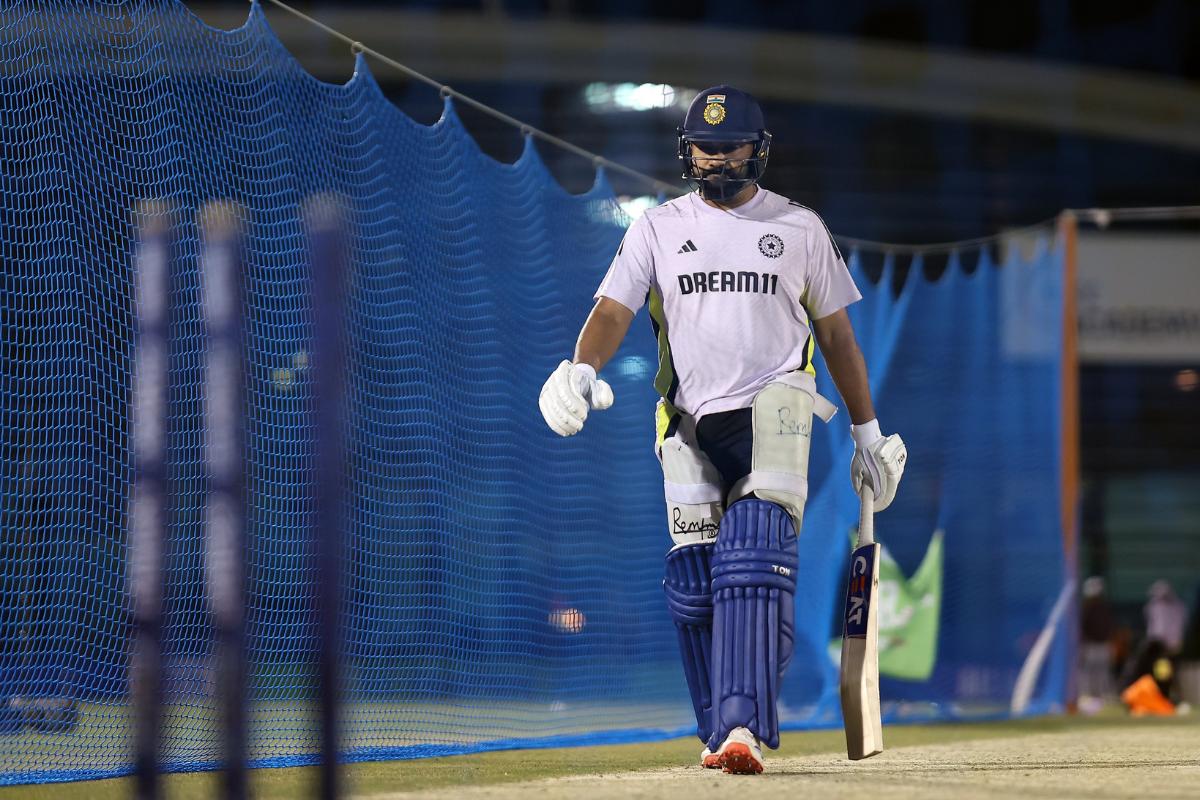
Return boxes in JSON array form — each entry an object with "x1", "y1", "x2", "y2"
[{"x1": 0, "y1": 711, "x2": 1200, "y2": 800}]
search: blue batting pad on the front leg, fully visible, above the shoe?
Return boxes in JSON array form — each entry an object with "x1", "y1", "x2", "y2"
[{"x1": 713, "y1": 500, "x2": 799, "y2": 748}]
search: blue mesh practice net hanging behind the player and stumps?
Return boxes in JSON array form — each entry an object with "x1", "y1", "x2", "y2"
[{"x1": 0, "y1": 0, "x2": 1068, "y2": 783}]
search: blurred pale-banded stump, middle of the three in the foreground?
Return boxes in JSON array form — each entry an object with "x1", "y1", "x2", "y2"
[{"x1": 200, "y1": 201, "x2": 247, "y2": 800}]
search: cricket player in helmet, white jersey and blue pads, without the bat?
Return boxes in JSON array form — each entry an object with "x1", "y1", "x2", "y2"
[{"x1": 539, "y1": 85, "x2": 906, "y2": 772}]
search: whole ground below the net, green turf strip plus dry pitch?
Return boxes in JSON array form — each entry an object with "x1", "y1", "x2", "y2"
[{"x1": 0, "y1": 709, "x2": 1200, "y2": 800}]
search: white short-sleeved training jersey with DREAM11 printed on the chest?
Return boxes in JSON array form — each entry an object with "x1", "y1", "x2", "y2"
[{"x1": 595, "y1": 187, "x2": 862, "y2": 420}]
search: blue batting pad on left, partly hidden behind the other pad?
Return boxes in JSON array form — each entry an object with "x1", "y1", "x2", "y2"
[{"x1": 662, "y1": 542, "x2": 713, "y2": 744}]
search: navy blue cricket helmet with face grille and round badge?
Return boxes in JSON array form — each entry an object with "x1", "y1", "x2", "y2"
[{"x1": 679, "y1": 84, "x2": 770, "y2": 200}]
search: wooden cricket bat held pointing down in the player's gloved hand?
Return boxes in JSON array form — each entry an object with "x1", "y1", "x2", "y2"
[{"x1": 841, "y1": 487, "x2": 883, "y2": 762}]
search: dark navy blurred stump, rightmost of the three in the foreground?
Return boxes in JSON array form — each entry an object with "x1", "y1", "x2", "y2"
[{"x1": 305, "y1": 196, "x2": 347, "y2": 800}]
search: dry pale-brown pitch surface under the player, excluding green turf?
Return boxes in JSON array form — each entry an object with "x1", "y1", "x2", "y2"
[{"x1": 370, "y1": 724, "x2": 1200, "y2": 800}]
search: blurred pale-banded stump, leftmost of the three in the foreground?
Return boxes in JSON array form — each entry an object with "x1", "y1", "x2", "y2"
[{"x1": 128, "y1": 201, "x2": 172, "y2": 800}]
